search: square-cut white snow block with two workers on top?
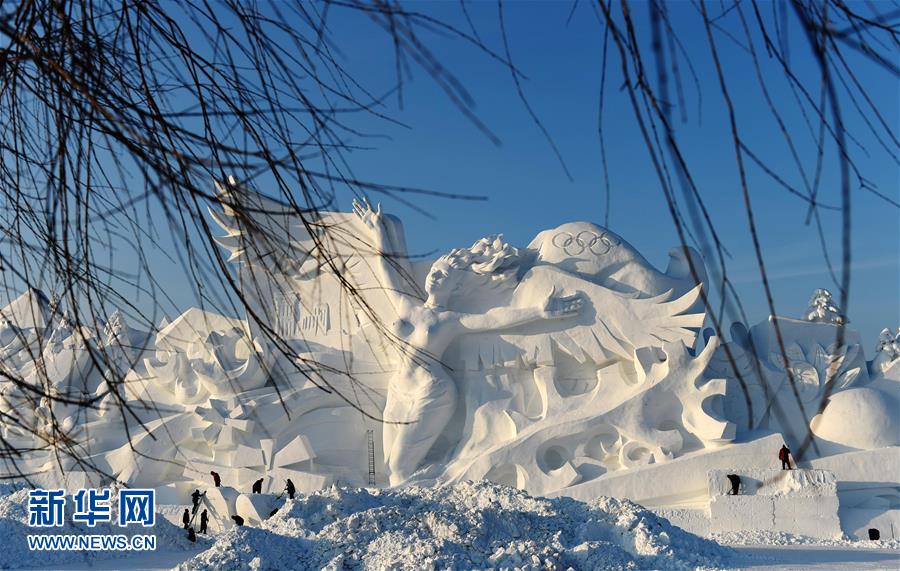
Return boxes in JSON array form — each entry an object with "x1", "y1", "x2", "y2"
[{"x1": 709, "y1": 470, "x2": 842, "y2": 539}]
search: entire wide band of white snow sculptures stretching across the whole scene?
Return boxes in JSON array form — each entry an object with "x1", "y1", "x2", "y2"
[{"x1": 0, "y1": 180, "x2": 900, "y2": 540}]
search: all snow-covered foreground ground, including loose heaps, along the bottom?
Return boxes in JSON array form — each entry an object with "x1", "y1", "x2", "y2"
[{"x1": 0, "y1": 482, "x2": 900, "y2": 571}]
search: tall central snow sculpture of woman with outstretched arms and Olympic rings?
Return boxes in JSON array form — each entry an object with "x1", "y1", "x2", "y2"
[{"x1": 207, "y1": 185, "x2": 720, "y2": 492}]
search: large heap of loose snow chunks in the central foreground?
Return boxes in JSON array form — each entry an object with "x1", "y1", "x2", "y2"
[{"x1": 179, "y1": 481, "x2": 732, "y2": 571}]
